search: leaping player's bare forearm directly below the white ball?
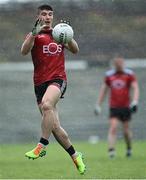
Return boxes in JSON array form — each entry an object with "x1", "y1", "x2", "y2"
[{"x1": 65, "y1": 39, "x2": 79, "y2": 54}]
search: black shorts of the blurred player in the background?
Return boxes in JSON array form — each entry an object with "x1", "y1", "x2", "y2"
[{"x1": 109, "y1": 108, "x2": 131, "y2": 121}]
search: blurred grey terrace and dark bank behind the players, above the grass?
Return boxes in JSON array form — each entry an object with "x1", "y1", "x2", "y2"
[{"x1": 0, "y1": 0, "x2": 146, "y2": 143}]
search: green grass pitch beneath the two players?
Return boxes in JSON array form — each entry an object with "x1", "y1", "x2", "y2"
[{"x1": 0, "y1": 142, "x2": 146, "y2": 179}]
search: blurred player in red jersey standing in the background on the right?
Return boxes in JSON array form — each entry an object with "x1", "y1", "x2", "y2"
[{"x1": 95, "y1": 56, "x2": 139, "y2": 157}]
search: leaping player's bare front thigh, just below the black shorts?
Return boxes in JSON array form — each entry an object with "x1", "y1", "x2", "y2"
[{"x1": 41, "y1": 84, "x2": 61, "y2": 107}]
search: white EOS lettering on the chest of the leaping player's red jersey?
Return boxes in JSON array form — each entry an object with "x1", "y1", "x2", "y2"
[{"x1": 43, "y1": 43, "x2": 62, "y2": 55}]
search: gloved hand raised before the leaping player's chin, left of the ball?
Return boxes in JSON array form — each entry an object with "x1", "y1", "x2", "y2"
[{"x1": 32, "y1": 19, "x2": 46, "y2": 36}]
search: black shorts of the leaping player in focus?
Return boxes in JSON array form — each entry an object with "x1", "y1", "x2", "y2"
[{"x1": 34, "y1": 79, "x2": 67, "y2": 104}]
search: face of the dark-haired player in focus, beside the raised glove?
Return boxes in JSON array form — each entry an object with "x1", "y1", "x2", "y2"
[{"x1": 38, "y1": 10, "x2": 53, "y2": 28}]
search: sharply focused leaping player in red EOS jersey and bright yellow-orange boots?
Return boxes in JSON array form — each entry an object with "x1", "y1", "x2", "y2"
[{"x1": 21, "y1": 5, "x2": 85, "y2": 174}]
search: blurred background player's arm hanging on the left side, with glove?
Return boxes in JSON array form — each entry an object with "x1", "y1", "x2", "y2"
[{"x1": 95, "y1": 83, "x2": 108, "y2": 115}]
